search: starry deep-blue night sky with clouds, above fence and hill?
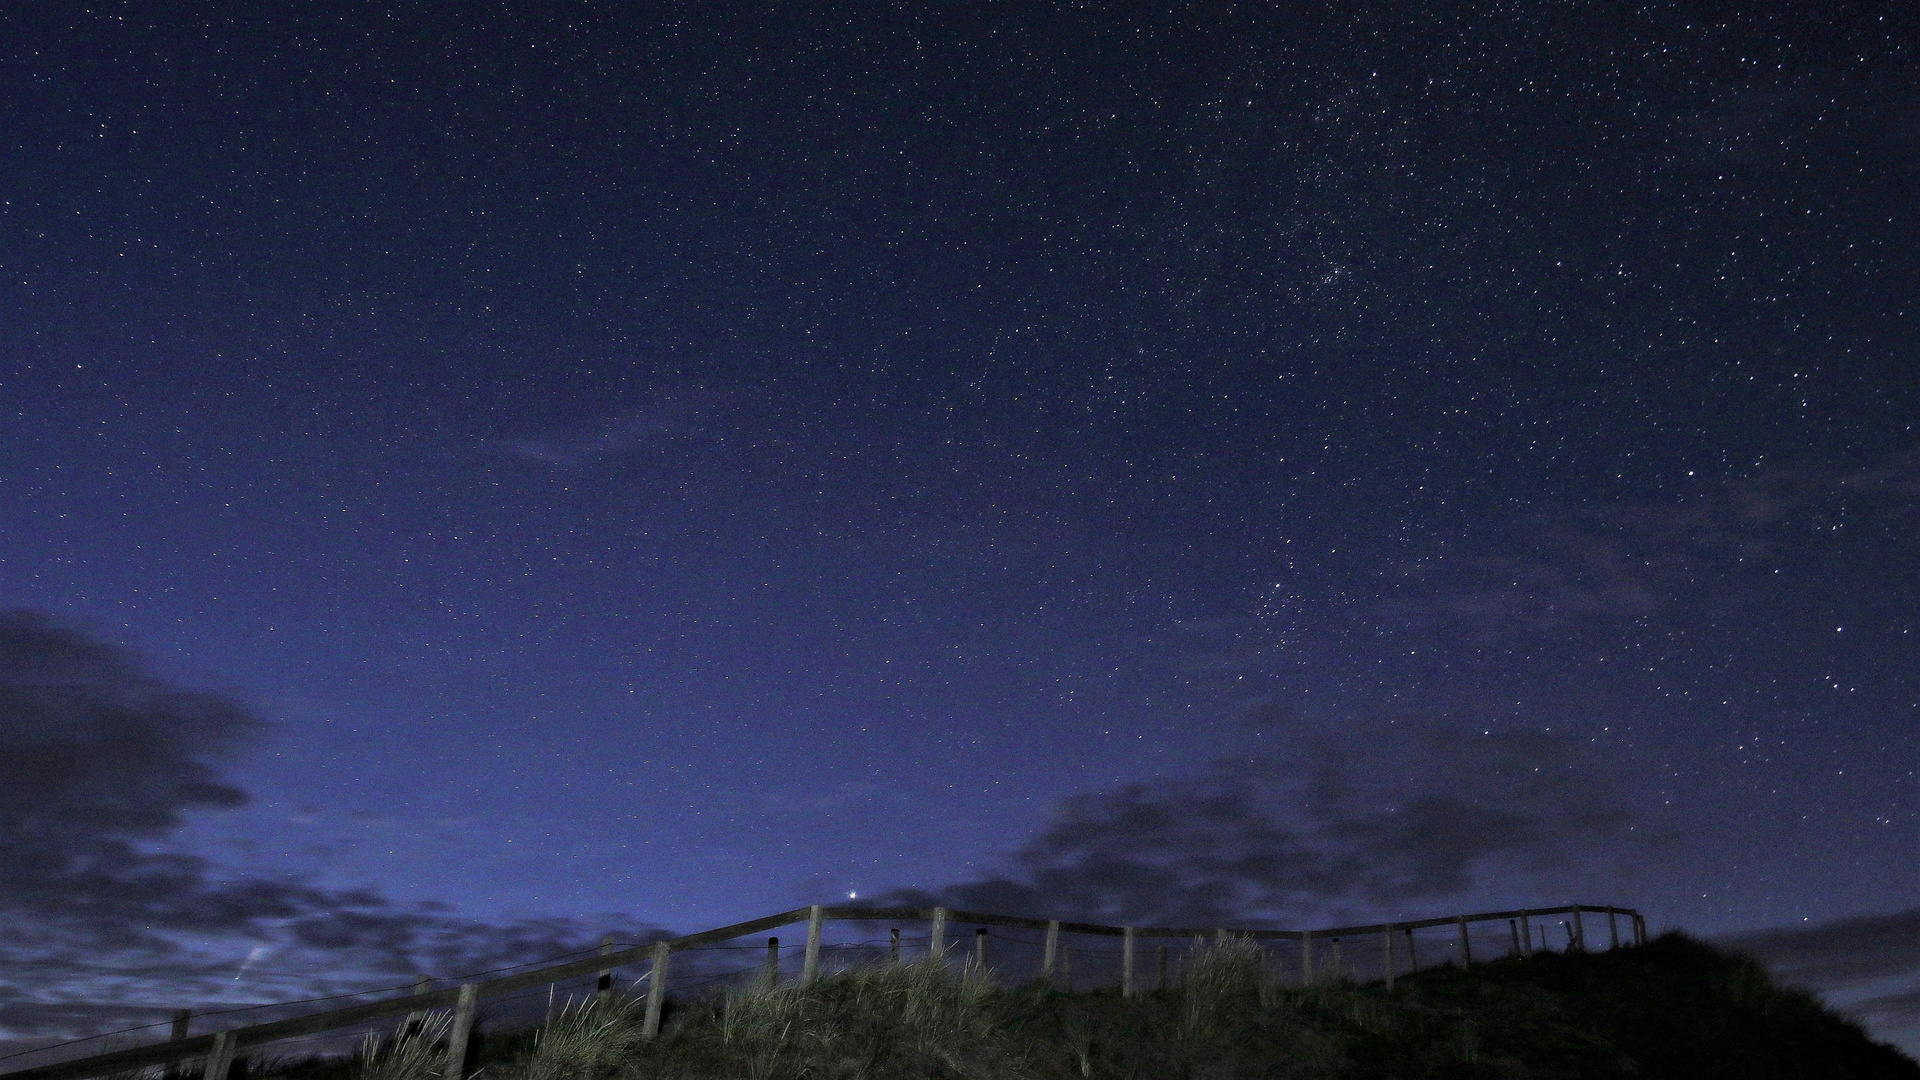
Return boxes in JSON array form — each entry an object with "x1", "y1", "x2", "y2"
[{"x1": 0, "y1": 0, "x2": 1920, "y2": 1045}]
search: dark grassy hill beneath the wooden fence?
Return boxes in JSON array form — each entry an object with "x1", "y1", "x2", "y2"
[{"x1": 337, "y1": 934, "x2": 1920, "y2": 1080}]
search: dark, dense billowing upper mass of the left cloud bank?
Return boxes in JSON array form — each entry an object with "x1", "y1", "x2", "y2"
[{"x1": 0, "y1": 611, "x2": 274, "y2": 945}]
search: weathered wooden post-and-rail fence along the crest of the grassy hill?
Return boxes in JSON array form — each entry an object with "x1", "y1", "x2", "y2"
[{"x1": 0, "y1": 903, "x2": 1647, "y2": 1080}]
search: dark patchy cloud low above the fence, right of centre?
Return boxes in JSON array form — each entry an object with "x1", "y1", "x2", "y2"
[{"x1": 890, "y1": 721, "x2": 1655, "y2": 926}]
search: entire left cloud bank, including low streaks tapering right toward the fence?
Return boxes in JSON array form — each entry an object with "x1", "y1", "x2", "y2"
[{"x1": 0, "y1": 611, "x2": 657, "y2": 1038}]
